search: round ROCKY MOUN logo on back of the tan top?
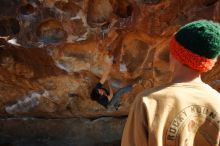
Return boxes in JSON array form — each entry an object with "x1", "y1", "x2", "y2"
[{"x1": 165, "y1": 105, "x2": 220, "y2": 146}]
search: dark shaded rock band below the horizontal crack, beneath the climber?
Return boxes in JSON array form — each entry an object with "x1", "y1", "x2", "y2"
[{"x1": 0, "y1": 117, "x2": 125, "y2": 146}]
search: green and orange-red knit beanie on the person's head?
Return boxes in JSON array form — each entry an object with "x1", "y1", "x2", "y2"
[{"x1": 170, "y1": 20, "x2": 220, "y2": 72}]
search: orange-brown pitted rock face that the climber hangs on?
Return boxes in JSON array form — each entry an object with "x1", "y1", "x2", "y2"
[{"x1": 0, "y1": 0, "x2": 220, "y2": 146}]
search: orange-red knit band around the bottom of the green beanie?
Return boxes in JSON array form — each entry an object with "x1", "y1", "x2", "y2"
[{"x1": 170, "y1": 37, "x2": 215, "y2": 72}]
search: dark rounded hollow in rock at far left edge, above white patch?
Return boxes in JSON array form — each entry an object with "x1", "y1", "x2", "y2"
[{"x1": 0, "y1": 18, "x2": 20, "y2": 36}]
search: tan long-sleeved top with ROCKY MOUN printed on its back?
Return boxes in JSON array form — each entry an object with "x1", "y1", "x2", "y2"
[{"x1": 121, "y1": 83, "x2": 220, "y2": 146}]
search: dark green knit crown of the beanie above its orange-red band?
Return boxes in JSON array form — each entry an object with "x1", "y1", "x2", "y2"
[{"x1": 175, "y1": 20, "x2": 220, "y2": 59}]
